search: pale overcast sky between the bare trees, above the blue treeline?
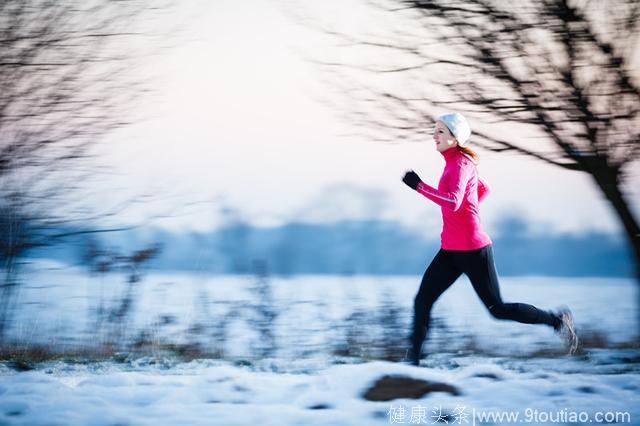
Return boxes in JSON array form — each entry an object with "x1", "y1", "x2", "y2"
[{"x1": 90, "y1": 0, "x2": 640, "y2": 236}]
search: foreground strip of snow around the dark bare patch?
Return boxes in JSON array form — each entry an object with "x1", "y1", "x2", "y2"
[{"x1": 0, "y1": 353, "x2": 640, "y2": 426}]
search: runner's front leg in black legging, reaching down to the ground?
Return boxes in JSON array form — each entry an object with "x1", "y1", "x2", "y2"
[{"x1": 410, "y1": 250, "x2": 462, "y2": 365}]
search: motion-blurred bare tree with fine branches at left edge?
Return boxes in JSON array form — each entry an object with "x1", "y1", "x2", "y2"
[{"x1": 0, "y1": 0, "x2": 175, "y2": 339}]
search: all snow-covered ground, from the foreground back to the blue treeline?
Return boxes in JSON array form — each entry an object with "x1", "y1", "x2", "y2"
[{"x1": 0, "y1": 269, "x2": 640, "y2": 426}]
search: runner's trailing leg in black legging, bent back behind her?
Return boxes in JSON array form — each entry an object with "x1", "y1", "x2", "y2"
[{"x1": 455, "y1": 245, "x2": 562, "y2": 328}]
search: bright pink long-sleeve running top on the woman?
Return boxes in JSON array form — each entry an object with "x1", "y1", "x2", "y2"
[{"x1": 416, "y1": 148, "x2": 491, "y2": 250}]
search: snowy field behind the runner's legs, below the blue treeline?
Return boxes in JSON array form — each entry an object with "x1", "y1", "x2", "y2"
[{"x1": 11, "y1": 268, "x2": 640, "y2": 359}]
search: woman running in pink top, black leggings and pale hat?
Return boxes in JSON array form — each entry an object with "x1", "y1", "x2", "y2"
[{"x1": 402, "y1": 113, "x2": 578, "y2": 365}]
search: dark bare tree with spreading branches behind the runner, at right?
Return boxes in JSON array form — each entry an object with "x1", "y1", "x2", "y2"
[{"x1": 295, "y1": 0, "x2": 640, "y2": 280}]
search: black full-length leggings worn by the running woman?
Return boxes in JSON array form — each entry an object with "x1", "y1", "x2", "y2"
[{"x1": 411, "y1": 245, "x2": 560, "y2": 360}]
